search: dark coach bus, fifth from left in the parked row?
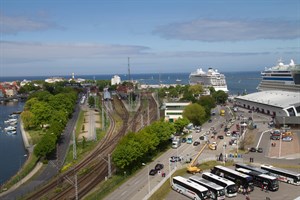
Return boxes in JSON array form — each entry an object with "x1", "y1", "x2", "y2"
[{"x1": 235, "y1": 168, "x2": 279, "y2": 191}]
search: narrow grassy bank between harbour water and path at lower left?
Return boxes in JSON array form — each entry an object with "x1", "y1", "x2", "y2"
[{"x1": 1, "y1": 154, "x2": 38, "y2": 192}]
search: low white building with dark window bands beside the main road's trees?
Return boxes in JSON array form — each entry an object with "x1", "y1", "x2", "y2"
[{"x1": 164, "y1": 102, "x2": 191, "y2": 122}]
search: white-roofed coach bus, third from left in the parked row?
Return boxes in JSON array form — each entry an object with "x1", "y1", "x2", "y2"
[{"x1": 202, "y1": 172, "x2": 237, "y2": 197}]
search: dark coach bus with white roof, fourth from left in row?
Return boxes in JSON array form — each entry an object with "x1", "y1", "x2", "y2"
[{"x1": 211, "y1": 165, "x2": 254, "y2": 191}]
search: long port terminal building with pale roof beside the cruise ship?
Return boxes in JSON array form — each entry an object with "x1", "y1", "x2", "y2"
[{"x1": 235, "y1": 90, "x2": 300, "y2": 126}]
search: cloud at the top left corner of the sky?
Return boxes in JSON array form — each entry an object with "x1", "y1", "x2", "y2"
[{"x1": 0, "y1": 13, "x2": 62, "y2": 34}]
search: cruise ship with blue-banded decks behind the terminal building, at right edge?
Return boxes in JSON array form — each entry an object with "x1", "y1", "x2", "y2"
[{"x1": 257, "y1": 59, "x2": 300, "y2": 92}]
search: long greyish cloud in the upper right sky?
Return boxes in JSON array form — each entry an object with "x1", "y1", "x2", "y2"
[{"x1": 154, "y1": 19, "x2": 300, "y2": 42}]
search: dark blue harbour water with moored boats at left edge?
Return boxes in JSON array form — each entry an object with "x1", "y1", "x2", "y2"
[{"x1": 0, "y1": 102, "x2": 27, "y2": 185}]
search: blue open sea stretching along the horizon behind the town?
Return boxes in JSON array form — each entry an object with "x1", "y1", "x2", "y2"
[{"x1": 0, "y1": 71, "x2": 261, "y2": 94}]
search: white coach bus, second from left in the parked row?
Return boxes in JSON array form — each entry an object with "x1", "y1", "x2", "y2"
[{"x1": 189, "y1": 176, "x2": 225, "y2": 200}]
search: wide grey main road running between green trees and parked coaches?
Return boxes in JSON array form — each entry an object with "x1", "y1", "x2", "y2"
[{"x1": 105, "y1": 105, "x2": 225, "y2": 200}]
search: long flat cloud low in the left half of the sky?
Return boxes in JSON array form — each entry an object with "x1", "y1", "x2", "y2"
[{"x1": 0, "y1": 41, "x2": 148, "y2": 63}]
